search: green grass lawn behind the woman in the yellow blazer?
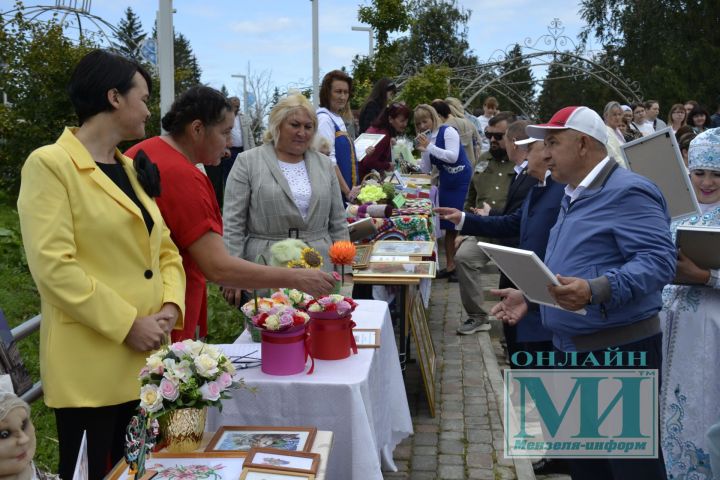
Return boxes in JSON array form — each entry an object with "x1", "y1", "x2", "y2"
[{"x1": 0, "y1": 194, "x2": 242, "y2": 472}]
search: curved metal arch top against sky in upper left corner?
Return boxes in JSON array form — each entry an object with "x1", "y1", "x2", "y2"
[{"x1": 0, "y1": 0, "x2": 139, "y2": 53}]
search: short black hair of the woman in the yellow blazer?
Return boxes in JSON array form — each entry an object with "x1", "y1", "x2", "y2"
[{"x1": 68, "y1": 50, "x2": 152, "y2": 125}]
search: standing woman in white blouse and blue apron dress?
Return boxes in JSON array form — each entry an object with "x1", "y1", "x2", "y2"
[{"x1": 414, "y1": 104, "x2": 472, "y2": 278}]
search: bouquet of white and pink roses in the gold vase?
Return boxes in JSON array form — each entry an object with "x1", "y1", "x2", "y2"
[{"x1": 139, "y1": 340, "x2": 242, "y2": 417}]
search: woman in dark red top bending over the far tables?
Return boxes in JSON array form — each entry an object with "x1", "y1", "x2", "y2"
[{"x1": 360, "y1": 103, "x2": 410, "y2": 178}]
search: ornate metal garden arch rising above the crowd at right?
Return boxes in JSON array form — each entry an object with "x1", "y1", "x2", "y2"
[{"x1": 396, "y1": 18, "x2": 643, "y2": 118}]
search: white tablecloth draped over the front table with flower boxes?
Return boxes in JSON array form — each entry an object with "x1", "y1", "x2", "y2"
[{"x1": 207, "y1": 300, "x2": 412, "y2": 480}]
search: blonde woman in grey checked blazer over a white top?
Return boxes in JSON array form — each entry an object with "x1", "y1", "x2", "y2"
[{"x1": 223, "y1": 94, "x2": 349, "y2": 271}]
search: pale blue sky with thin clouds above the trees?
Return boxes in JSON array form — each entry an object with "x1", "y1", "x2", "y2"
[{"x1": 5, "y1": 0, "x2": 596, "y2": 99}]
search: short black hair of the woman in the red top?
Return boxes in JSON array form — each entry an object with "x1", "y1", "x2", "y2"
[{"x1": 162, "y1": 85, "x2": 233, "y2": 135}]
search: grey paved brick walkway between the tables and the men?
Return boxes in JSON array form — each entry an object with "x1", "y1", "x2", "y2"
[{"x1": 384, "y1": 266, "x2": 568, "y2": 480}]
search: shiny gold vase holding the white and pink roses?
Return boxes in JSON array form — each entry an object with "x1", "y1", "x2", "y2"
[{"x1": 159, "y1": 408, "x2": 207, "y2": 453}]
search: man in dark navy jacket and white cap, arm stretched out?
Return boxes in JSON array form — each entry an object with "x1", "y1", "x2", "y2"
[{"x1": 435, "y1": 137, "x2": 565, "y2": 360}]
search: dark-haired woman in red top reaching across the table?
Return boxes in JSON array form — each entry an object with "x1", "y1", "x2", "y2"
[{"x1": 125, "y1": 86, "x2": 334, "y2": 341}]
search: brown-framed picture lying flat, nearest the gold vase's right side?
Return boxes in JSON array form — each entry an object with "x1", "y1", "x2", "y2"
[{"x1": 205, "y1": 426, "x2": 317, "y2": 455}]
